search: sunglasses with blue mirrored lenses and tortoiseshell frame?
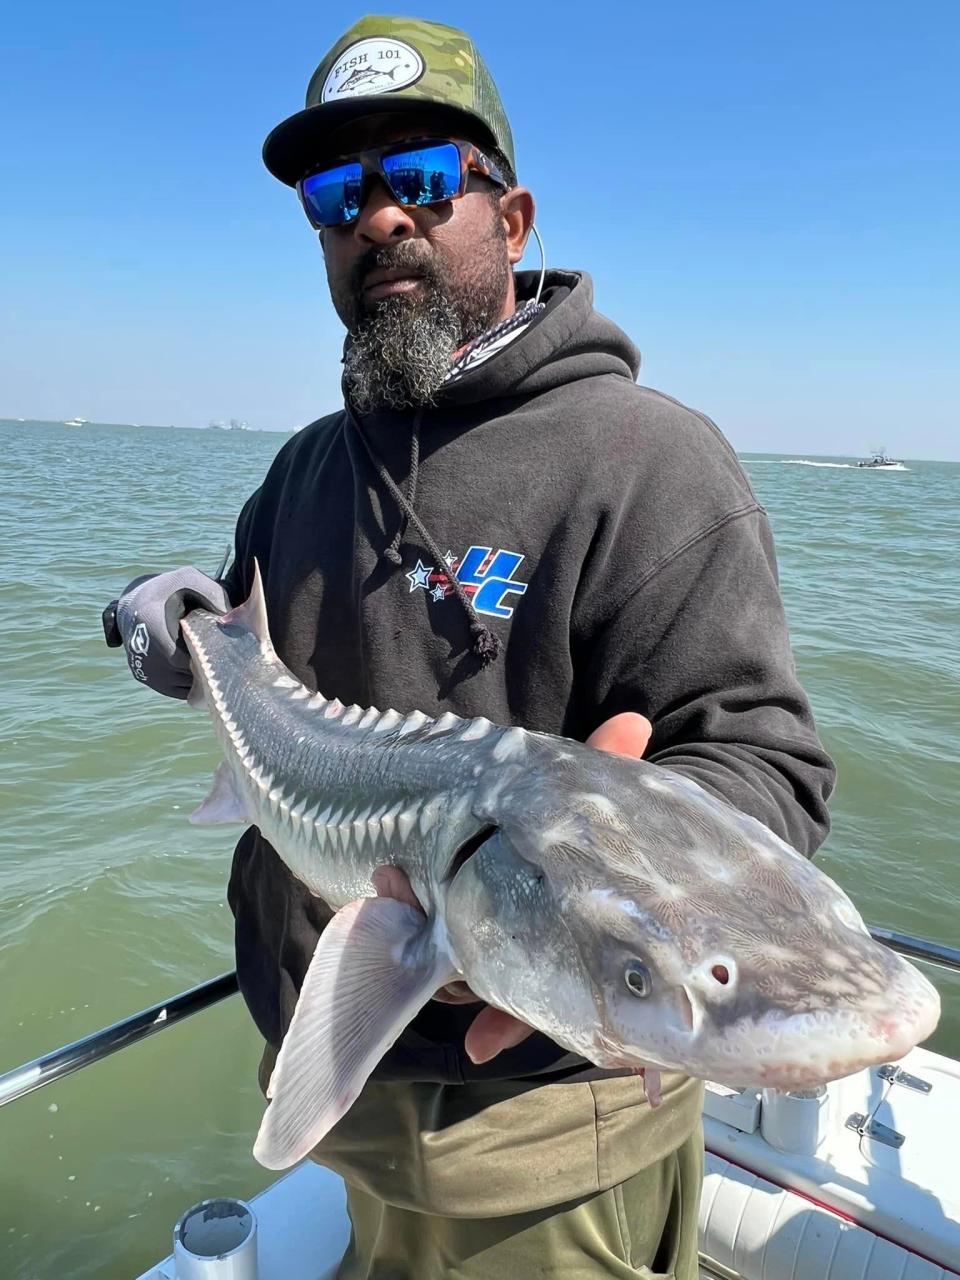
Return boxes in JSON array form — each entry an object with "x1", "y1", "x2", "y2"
[{"x1": 297, "y1": 138, "x2": 508, "y2": 230}]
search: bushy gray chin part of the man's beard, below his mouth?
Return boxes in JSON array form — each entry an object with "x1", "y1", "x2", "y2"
[{"x1": 343, "y1": 287, "x2": 468, "y2": 413}]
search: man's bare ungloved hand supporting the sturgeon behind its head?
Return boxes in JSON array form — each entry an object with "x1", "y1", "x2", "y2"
[{"x1": 372, "y1": 712, "x2": 653, "y2": 1064}]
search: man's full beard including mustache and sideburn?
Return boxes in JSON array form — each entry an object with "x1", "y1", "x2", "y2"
[{"x1": 332, "y1": 216, "x2": 509, "y2": 413}]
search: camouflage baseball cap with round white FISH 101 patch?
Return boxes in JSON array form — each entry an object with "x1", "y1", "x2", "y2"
[{"x1": 264, "y1": 17, "x2": 516, "y2": 187}]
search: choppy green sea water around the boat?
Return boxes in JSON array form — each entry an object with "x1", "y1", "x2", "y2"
[{"x1": 0, "y1": 421, "x2": 960, "y2": 1280}]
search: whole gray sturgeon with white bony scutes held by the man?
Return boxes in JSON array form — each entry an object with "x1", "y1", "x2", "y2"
[{"x1": 182, "y1": 571, "x2": 940, "y2": 1169}]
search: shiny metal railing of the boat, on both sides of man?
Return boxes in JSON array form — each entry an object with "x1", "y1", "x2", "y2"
[{"x1": 0, "y1": 927, "x2": 960, "y2": 1107}]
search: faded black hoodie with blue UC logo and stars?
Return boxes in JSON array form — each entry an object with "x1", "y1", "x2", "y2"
[{"x1": 227, "y1": 271, "x2": 833, "y2": 1082}]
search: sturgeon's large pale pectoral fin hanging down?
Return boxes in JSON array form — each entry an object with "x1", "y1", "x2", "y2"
[{"x1": 253, "y1": 897, "x2": 457, "y2": 1169}]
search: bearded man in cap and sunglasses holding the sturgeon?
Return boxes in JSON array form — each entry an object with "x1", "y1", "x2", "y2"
[{"x1": 108, "y1": 18, "x2": 832, "y2": 1280}]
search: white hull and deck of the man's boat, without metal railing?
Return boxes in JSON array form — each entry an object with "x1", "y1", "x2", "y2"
[{"x1": 140, "y1": 1048, "x2": 960, "y2": 1280}]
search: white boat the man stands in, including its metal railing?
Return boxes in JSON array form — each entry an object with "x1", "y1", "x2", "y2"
[{"x1": 0, "y1": 929, "x2": 960, "y2": 1280}]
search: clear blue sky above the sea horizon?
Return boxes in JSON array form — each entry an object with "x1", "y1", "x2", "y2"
[{"x1": 0, "y1": 0, "x2": 960, "y2": 460}]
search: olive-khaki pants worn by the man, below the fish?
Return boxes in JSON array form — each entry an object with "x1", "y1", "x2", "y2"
[{"x1": 260, "y1": 1047, "x2": 703, "y2": 1280}]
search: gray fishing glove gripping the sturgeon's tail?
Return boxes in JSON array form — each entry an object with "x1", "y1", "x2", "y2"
[{"x1": 102, "y1": 566, "x2": 230, "y2": 699}]
